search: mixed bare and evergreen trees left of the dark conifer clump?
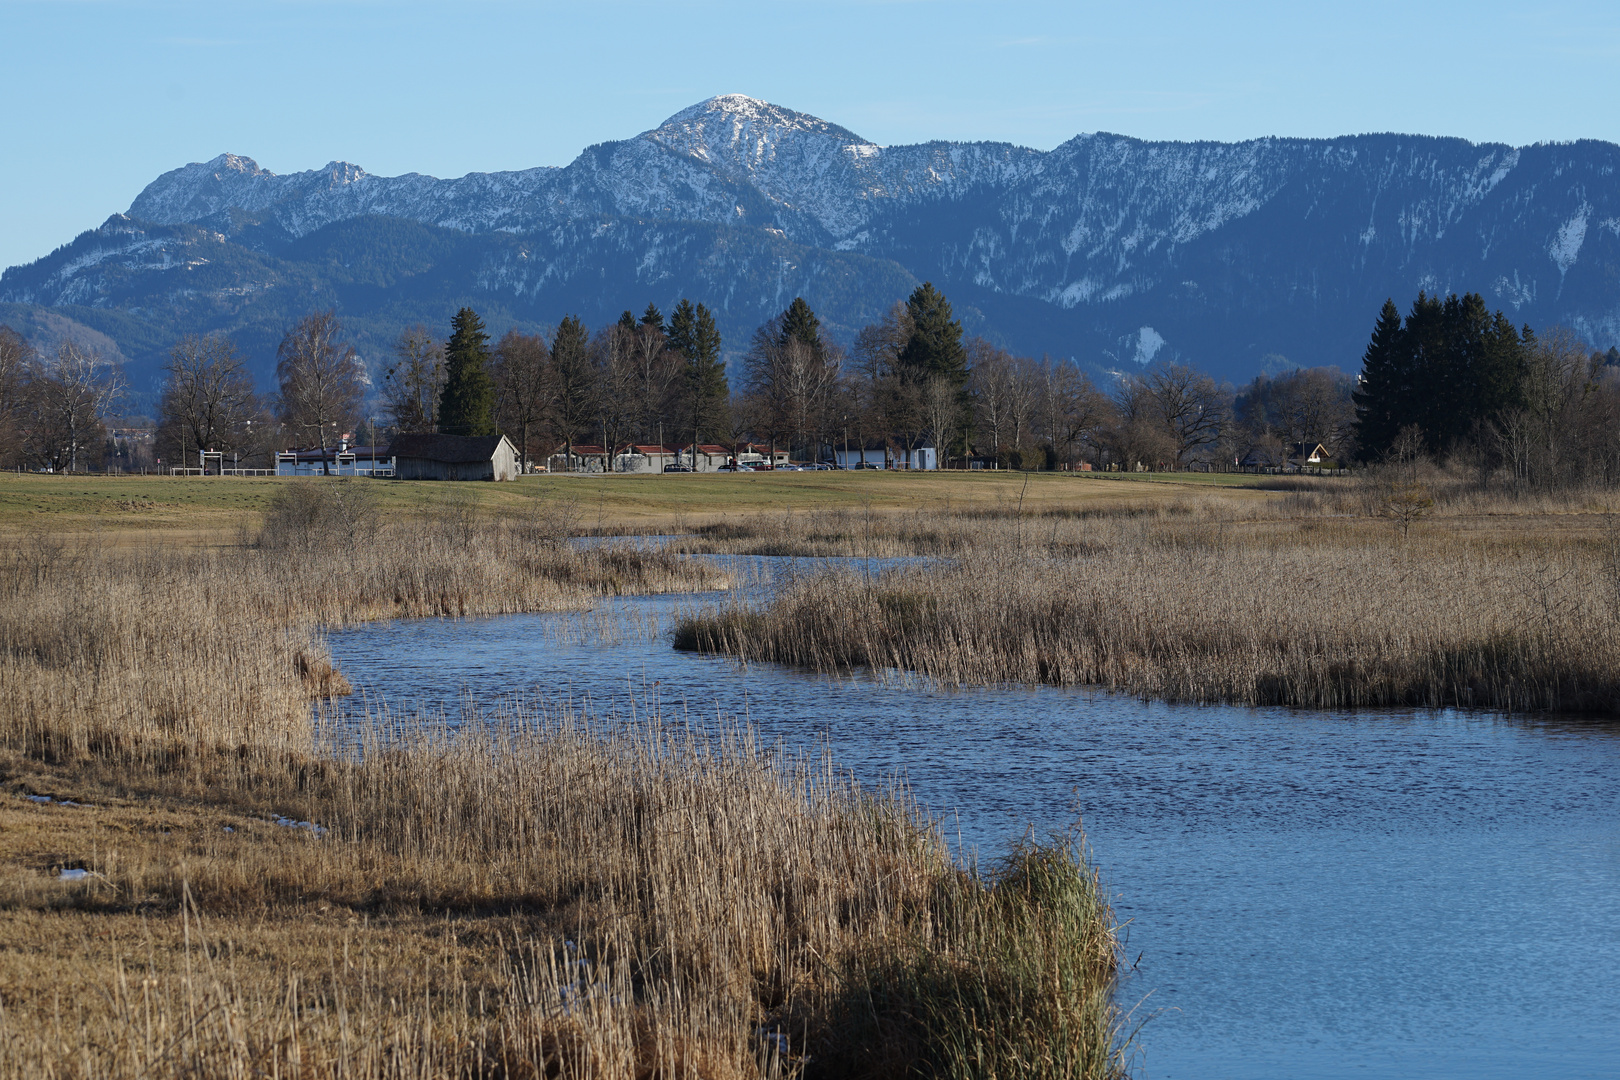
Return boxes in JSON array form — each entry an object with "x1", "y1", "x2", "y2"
[{"x1": 0, "y1": 283, "x2": 1367, "y2": 468}]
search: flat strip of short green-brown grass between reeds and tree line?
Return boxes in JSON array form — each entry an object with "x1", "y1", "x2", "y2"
[{"x1": 0, "y1": 471, "x2": 1277, "y2": 541}]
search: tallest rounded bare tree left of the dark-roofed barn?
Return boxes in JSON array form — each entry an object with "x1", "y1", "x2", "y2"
[{"x1": 275, "y1": 311, "x2": 366, "y2": 471}]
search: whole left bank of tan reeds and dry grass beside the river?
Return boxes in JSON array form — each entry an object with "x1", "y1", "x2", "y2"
[{"x1": 0, "y1": 481, "x2": 1123, "y2": 1080}]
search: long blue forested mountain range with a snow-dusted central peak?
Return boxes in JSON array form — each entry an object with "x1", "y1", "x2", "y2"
[{"x1": 0, "y1": 96, "x2": 1620, "y2": 388}]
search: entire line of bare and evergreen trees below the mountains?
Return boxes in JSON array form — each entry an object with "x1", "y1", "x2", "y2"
[{"x1": 15, "y1": 283, "x2": 1620, "y2": 483}]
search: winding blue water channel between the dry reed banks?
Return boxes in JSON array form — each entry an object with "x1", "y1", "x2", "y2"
[{"x1": 330, "y1": 559, "x2": 1620, "y2": 1080}]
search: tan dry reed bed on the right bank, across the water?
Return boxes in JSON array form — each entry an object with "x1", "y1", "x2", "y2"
[{"x1": 677, "y1": 501, "x2": 1620, "y2": 712}]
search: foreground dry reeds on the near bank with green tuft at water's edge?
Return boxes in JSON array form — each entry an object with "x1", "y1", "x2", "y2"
[{"x1": 0, "y1": 709, "x2": 1123, "y2": 1080}]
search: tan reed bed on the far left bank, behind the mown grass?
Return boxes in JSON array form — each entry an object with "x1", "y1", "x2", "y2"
[{"x1": 0, "y1": 501, "x2": 727, "y2": 761}]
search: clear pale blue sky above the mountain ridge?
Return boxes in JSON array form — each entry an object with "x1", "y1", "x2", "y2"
[{"x1": 0, "y1": 0, "x2": 1620, "y2": 267}]
